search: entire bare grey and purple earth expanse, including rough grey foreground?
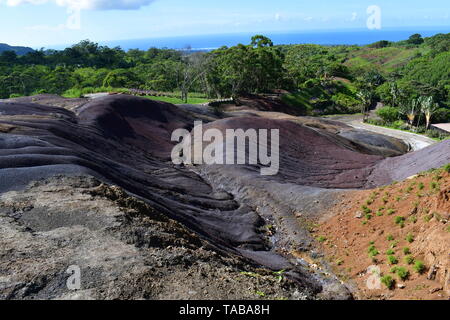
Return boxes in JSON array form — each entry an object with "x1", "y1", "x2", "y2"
[{"x1": 0, "y1": 95, "x2": 450, "y2": 299}]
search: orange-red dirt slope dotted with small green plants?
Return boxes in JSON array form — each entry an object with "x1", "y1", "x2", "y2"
[{"x1": 315, "y1": 170, "x2": 450, "y2": 300}]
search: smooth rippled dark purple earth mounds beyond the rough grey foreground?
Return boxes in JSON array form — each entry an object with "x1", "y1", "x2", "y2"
[{"x1": 0, "y1": 95, "x2": 450, "y2": 298}]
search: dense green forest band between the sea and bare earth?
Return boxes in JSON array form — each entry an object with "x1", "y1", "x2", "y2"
[{"x1": 0, "y1": 34, "x2": 450, "y2": 127}]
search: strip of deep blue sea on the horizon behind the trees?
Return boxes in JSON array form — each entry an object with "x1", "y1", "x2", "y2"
[{"x1": 100, "y1": 26, "x2": 450, "y2": 50}]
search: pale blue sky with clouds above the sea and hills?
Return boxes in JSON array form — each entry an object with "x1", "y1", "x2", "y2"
[{"x1": 0, "y1": 0, "x2": 450, "y2": 48}]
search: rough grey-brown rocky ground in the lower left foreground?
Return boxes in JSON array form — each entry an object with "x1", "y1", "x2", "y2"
[{"x1": 0, "y1": 176, "x2": 311, "y2": 300}]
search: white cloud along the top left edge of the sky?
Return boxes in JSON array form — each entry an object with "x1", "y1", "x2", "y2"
[{"x1": 0, "y1": 0, "x2": 154, "y2": 10}]
